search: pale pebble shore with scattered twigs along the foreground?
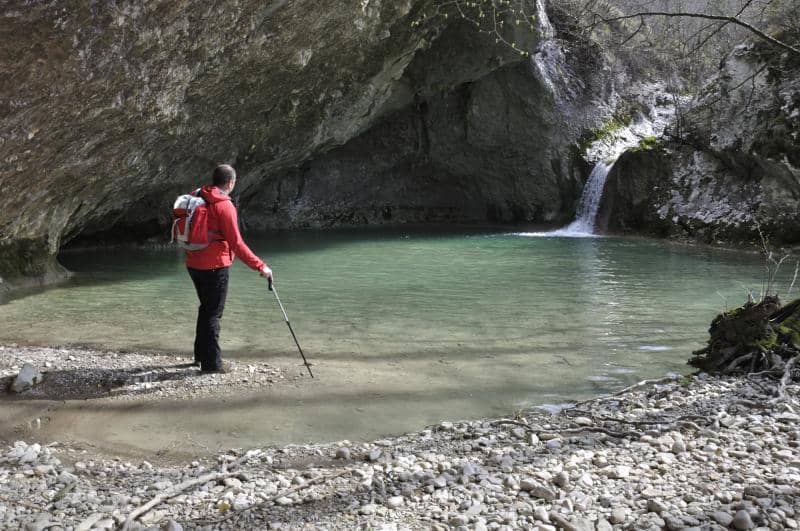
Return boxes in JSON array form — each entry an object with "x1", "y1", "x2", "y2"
[{"x1": 0, "y1": 344, "x2": 800, "y2": 530}]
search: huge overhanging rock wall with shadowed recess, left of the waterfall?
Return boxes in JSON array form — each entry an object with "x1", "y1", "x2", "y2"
[{"x1": 0, "y1": 0, "x2": 605, "y2": 290}]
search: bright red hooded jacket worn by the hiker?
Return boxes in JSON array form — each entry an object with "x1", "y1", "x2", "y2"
[{"x1": 186, "y1": 186, "x2": 265, "y2": 271}]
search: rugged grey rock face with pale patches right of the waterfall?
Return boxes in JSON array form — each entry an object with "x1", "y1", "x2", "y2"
[{"x1": 599, "y1": 45, "x2": 800, "y2": 244}]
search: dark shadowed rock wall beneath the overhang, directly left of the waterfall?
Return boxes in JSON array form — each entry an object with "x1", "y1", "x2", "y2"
[{"x1": 241, "y1": 58, "x2": 584, "y2": 228}]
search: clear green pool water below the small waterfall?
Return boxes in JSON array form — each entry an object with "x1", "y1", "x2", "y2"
[{"x1": 0, "y1": 231, "x2": 776, "y2": 454}]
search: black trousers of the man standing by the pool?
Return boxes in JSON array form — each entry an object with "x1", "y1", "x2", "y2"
[{"x1": 187, "y1": 267, "x2": 228, "y2": 371}]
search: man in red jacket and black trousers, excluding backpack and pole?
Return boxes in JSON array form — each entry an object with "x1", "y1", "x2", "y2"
[{"x1": 186, "y1": 164, "x2": 272, "y2": 372}]
